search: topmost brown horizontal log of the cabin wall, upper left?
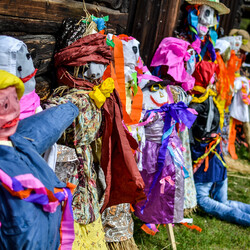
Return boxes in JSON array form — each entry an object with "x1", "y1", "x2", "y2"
[{"x1": 0, "y1": 0, "x2": 128, "y2": 28}]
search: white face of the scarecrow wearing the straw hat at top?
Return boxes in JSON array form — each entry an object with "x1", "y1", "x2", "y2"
[{"x1": 197, "y1": 5, "x2": 216, "y2": 37}]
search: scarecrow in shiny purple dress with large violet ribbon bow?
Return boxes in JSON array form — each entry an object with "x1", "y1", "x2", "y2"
[{"x1": 134, "y1": 78, "x2": 196, "y2": 224}]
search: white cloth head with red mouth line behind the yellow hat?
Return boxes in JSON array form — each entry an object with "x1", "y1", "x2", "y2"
[{"x1": 0, "y1": 36, "x2": 37, "y2": 95}]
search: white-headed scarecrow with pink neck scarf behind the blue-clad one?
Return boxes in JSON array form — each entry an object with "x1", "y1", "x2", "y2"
[{"x1": 0, "y1": 36, "x2": 57, "y2": 170}]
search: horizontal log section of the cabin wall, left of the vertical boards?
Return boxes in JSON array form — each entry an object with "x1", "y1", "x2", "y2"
[{"x1": 0, "y1": 0, "x2": 128, "y2": 98}]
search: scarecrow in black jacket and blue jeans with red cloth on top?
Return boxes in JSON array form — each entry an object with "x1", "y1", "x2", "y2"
[{"x1": 190, "y1": 61, "x2": 250, "y2": 226}]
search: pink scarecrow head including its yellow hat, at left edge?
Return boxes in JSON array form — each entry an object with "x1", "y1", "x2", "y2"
[{"x1": 0, "y1": 70, "x2": 24, "y2": 140}]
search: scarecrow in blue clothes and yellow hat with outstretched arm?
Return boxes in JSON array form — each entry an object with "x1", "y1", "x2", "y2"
[{"x1": 0, "y1": 70, "x2": 78, "y2": 249}]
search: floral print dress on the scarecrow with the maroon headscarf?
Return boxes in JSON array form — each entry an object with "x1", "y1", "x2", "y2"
[{"x1": 48, "y1": 87, "x2": 101, "y2": 224}]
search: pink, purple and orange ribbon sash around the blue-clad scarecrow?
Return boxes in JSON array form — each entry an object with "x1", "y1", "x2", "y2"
[{"x1": 0, "y1": 169, "x2": 75, "y2": 250}]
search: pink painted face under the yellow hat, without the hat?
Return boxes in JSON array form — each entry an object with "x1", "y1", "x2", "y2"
[{"x1": 0, "y1": 86, "x2": 20, "y2": 140}]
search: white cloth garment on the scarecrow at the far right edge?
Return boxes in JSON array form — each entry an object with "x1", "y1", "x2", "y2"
[{"x1": 230, "y1": 76, "x2": 249, "y2": 122}]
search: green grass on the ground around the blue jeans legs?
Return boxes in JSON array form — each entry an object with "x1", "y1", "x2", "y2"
[{"x1": 134, "y1": 173, "x2": 250, "y2": 250}]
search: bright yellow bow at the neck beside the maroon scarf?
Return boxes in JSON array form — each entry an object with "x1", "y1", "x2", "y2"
[{"x1": 89, "y1": 77, "x2": 115, "y2": 109}]
